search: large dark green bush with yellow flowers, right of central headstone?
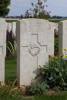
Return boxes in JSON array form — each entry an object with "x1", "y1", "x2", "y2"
[{"x1": 39, "y1": 57, "x2": 67, "y2": 90}]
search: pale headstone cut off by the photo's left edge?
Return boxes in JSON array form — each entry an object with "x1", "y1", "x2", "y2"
[{"x1": 0, "y1": 19, "x2": 7, "y2": 85}]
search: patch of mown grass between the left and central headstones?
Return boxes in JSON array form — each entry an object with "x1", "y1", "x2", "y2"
[{"x1": 5, "y1": 57, "x2": 17, "y2": 81}]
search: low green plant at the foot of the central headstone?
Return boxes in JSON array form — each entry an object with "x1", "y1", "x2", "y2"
[{"x1": 26, "y1": 82, "x2": 49, "y2": 95}]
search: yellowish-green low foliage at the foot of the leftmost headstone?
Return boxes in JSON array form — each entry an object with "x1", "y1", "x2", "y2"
[{"x1": 0, "y1": 80, "x2": 19, "y2": 97}]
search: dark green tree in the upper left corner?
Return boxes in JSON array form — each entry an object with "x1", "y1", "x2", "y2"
[{"x1": 0, "y1": 0, "x2": 10, "y2": 17}]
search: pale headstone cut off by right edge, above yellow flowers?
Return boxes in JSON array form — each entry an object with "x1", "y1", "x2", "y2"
[{"x1": 59, "y1": 20, "x2": 67, "y2": 58}]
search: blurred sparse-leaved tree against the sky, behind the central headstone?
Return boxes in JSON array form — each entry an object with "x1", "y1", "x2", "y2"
[{"x1": 25, "y1": 0, "x2": 50, "y2": 19}]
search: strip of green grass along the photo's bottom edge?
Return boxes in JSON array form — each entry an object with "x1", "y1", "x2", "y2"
[{"x1": 0, "y1": 93, "x2": 67, "y2": 100}]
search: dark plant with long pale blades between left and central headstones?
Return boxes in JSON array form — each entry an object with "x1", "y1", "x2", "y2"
[{"x1": 6, "y1": 31, "x2": 16, "y2": 56}]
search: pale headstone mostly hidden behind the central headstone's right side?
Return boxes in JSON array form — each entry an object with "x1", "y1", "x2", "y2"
[{"x1": 46, "y1": 22, "x2": 56, "y2": 57}]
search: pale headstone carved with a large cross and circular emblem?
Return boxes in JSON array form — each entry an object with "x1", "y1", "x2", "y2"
[{"x1": 16, "y1": 19, "x2": 49, "y2": 86}]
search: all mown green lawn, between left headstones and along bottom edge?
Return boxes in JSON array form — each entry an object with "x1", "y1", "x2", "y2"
[{"x1": 4, "y1": 58, "x2": 67, "y2": 100}]
